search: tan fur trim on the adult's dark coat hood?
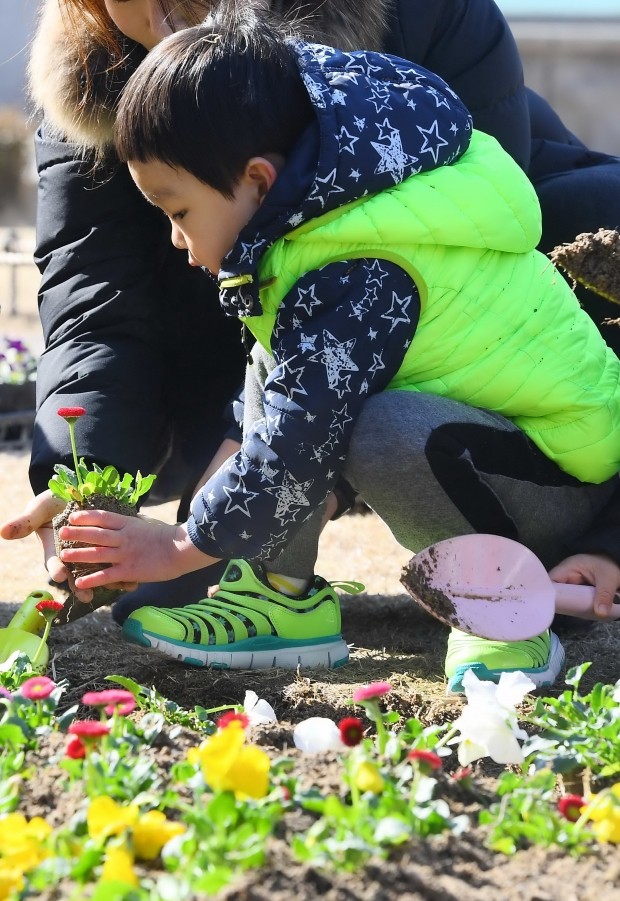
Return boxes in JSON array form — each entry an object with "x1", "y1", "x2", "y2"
[{"x1": 28, "y1": 0, "x2": 393, "y2": 151}]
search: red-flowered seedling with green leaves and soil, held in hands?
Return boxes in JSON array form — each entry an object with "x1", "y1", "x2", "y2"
[{"x1": 48, "y1": 407, "x2": 156, "y2": 622}]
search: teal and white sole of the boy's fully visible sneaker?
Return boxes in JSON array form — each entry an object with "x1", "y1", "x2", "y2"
[{"x1": 122, "y1": 619, "x2": 349, "y2": 670}]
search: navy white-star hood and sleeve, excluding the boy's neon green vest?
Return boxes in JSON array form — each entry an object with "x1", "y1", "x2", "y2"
[{"x1": 188, "y1": 41, "x2": 471, "y2": 559}]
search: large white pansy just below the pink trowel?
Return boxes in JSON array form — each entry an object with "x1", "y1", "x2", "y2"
[{"x1": 453, "y1": 670, "x2": 536, "y2": 766}]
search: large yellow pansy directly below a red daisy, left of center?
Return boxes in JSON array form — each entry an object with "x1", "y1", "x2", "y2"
[{"x1": 188, "y1": 722, "x2": 270, "y2": 798}]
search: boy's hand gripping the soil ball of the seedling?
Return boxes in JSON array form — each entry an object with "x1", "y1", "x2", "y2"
[{"x1": 59, "y1": 510, "x2": 217, "y2": 591}]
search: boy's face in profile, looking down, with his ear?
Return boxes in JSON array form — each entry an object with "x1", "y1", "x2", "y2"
[{"x1": 129, "y1": 158, "x2": 271, "y2": 275}]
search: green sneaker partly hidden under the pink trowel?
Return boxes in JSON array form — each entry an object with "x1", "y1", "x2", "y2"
[{"x1": 445, "y1": 629, "x2": 565, "y2": 694}]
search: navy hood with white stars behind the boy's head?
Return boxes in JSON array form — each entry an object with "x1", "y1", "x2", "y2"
[{"x1": 220, "y1": 40, "x2": 472, "y2": 315}]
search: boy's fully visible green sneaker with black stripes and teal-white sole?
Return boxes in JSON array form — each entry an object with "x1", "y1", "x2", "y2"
[{"x1": 123, "y1": 560, "x2": 362, "y2": 669}]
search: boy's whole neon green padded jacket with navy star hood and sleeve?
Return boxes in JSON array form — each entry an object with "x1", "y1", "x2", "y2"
[{"x1": 188, "y1": 41, "x2": 620, "y2": 559}]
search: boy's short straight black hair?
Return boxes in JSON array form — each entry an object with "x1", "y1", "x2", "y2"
[{"x1": 114, "y1": 4, "x2": 314, "y2": 198}]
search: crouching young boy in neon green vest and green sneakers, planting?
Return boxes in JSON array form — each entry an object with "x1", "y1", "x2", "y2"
[{"x1": 54, "y1": 11, "x2": 620, "y2": 691}]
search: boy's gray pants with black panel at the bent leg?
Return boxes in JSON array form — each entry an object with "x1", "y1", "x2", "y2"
[{"x1": 244, "y1": 345, "x2": 617, "y2": 578}]
